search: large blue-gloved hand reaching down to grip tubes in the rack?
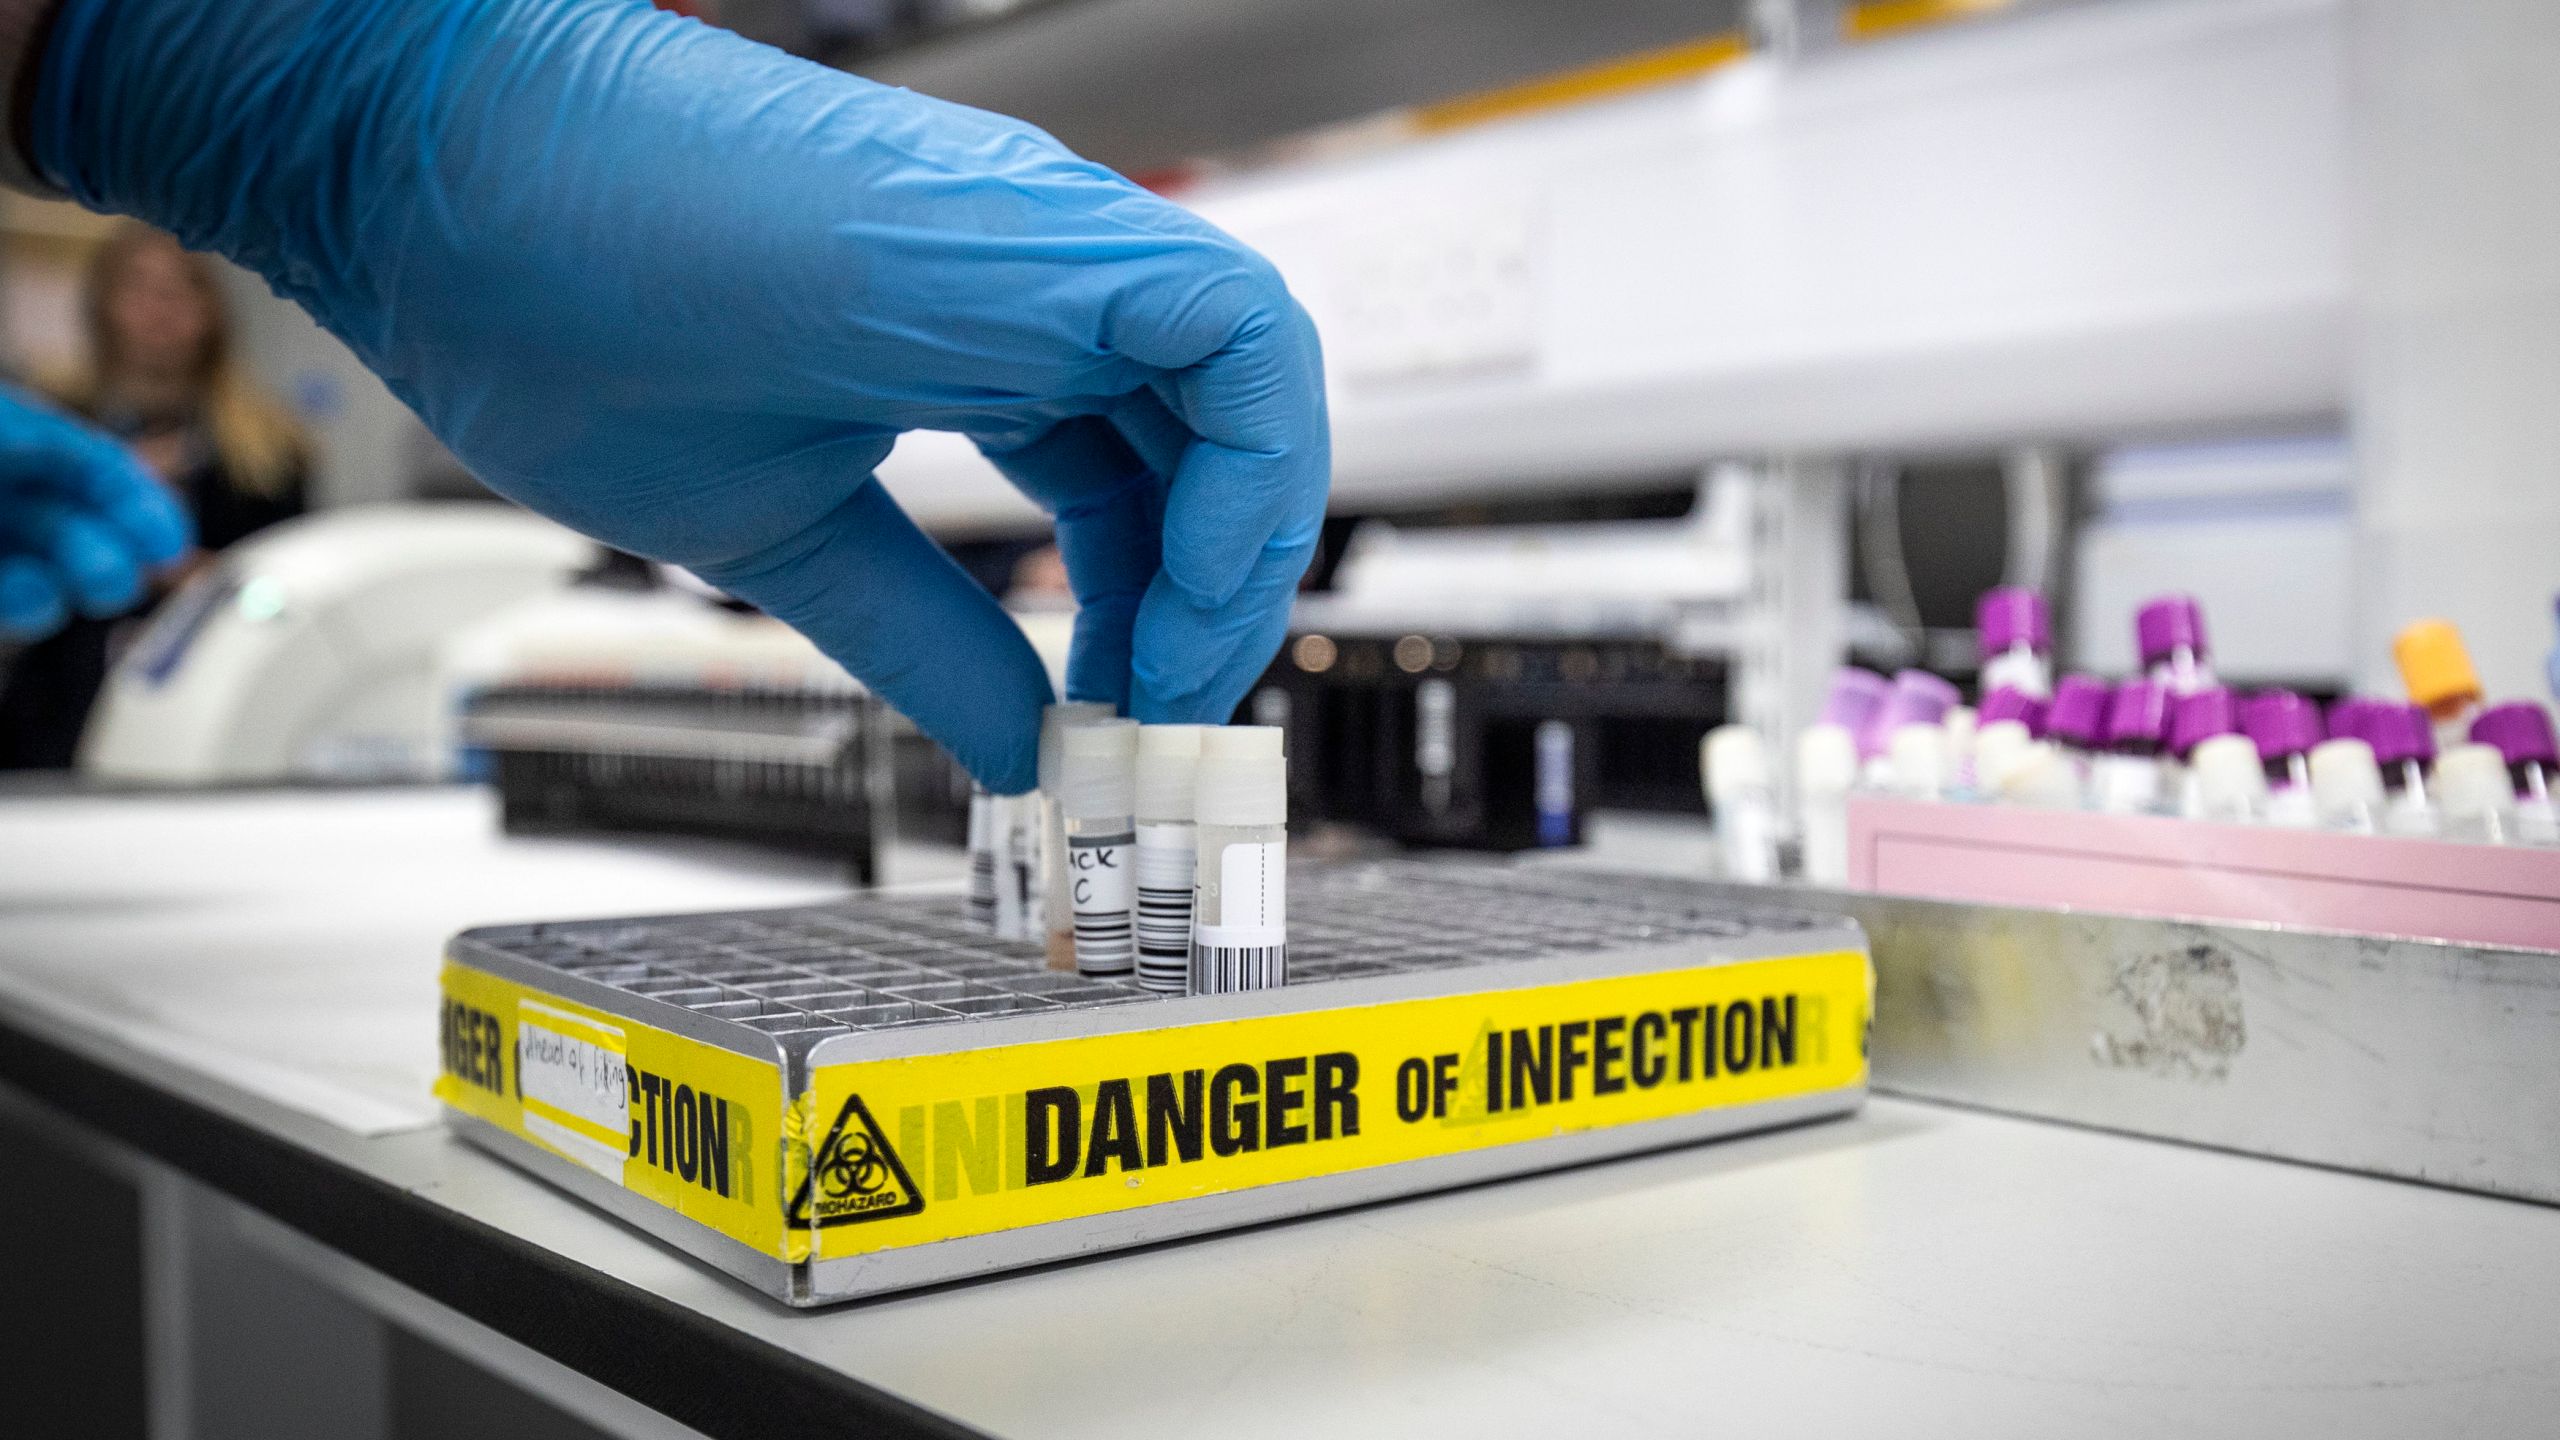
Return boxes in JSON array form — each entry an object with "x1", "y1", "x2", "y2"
[{"x1": 31, "y1": 0, "x2": 1329, "y2": 792}]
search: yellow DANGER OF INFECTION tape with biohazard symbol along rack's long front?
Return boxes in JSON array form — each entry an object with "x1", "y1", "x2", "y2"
[{"x1": 786, "y1": 951, "x2": 1871, "y2": 1258}]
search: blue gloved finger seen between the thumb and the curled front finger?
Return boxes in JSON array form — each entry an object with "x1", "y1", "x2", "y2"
[{"x1": 988, "y1": 415, "x2": 1165, "y2": 707}]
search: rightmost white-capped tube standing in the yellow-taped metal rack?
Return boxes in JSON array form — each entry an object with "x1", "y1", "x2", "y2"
[{"x1": 1190, "y1": 725, "x2": 1288, "y2": 994}]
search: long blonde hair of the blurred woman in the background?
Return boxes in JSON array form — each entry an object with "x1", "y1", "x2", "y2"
[{"x1": 46, "y1": 220, "x2": 312, "y2": 500}]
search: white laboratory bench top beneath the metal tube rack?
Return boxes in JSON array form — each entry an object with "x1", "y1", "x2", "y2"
[{"x1": 0, "y1": 789, "x2": 2560, "y2": 1437}]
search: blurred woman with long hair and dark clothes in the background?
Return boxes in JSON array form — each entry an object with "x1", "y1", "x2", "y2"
[{"x1": 0, "y1": 225, "x2": 312, "y2": 769}]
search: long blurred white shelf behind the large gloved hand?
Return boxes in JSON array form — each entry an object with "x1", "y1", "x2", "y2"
[{"x1": 883, "y1": 0, "x2": 2348, "y2": 530}]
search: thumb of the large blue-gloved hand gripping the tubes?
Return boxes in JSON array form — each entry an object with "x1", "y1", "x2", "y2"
[{"x1": 699, "y1": 482, "x2": 1050, "y2": 794}]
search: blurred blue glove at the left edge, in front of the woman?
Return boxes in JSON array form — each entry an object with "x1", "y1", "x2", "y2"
[{"x1": 0, "y1": 384, "x2": 195, "y2": 641}]
